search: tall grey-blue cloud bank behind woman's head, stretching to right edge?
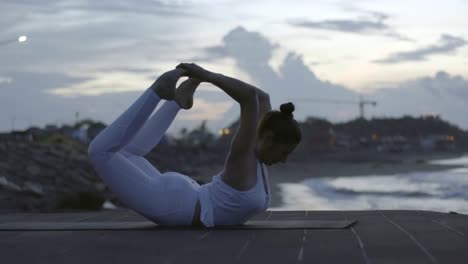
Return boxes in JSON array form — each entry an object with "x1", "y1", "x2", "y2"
[{"x1": 192, "y1": 27, "x2": 468, "y2": 128}]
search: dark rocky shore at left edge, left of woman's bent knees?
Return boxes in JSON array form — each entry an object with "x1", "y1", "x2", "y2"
[{"x1": 0, "y1": 141, "x2": 109, "y2": 212}]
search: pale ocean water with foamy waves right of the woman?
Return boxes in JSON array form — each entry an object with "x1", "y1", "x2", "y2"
[{"x1": 270, "y1": 155, "x2": 468, "y2": 214}]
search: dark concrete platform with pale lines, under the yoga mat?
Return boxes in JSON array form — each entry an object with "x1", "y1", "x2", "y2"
[{"x1": 0, "y1": 210, "x2": 468, "y2": 264}]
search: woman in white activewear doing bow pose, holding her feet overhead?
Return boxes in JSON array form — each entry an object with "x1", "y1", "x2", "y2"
[{"x1": 88, "y1": 63, "x2": 301, "y2": 227}]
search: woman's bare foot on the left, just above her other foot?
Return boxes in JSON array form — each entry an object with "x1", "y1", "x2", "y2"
[{"x1": 151, "y1": 69, "x2": 187, "y2": 100}]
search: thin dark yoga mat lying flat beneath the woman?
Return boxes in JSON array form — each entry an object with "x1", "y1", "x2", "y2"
[{"x1": 0, "y1": 220, "x2": 356, "y2": 231}]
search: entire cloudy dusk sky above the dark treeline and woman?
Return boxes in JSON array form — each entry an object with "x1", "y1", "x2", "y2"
[{"x1": 0, "y1": 0, "x2": 468, "y2": 135}]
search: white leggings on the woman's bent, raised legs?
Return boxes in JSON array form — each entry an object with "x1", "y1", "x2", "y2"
[{"x1": 88, "y1": 88, "x2": 200, "y2": 225}]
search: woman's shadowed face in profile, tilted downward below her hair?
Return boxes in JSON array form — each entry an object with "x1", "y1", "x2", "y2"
[{"x1": 257, "y1": 132, "x2": 297, "y2": 166}]
